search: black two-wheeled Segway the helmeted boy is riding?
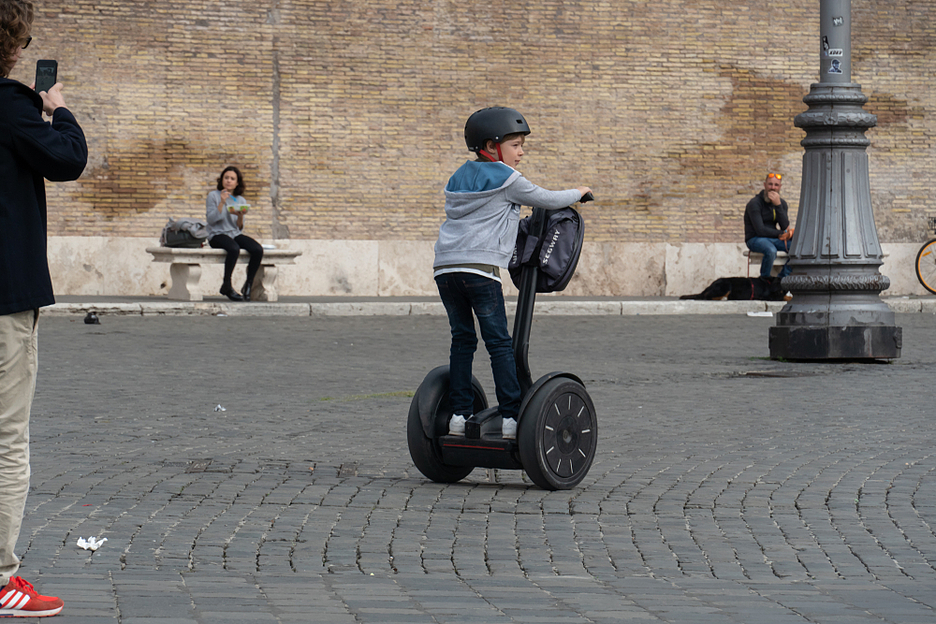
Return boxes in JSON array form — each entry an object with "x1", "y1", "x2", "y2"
[{"x1": 406, "y1": 193, "x2": 598, "y2": 490}]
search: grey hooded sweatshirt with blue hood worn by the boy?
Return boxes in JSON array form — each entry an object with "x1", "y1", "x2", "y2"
[{"x1": 432, "y1": 160, "x2": 582, "y2": 269}]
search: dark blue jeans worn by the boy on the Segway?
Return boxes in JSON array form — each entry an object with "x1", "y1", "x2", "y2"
[{"x1": 436, "y1": 273, "x2": 521, "y2": 418}]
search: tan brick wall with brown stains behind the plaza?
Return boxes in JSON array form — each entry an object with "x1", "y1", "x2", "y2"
[{"x1": 13, "y1": 0, "x2": 936, "y2": 242}]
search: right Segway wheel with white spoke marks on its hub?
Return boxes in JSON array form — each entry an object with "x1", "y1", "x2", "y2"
[{"x1": 517, "y1": 377, "x2": 598, "y2": 490}]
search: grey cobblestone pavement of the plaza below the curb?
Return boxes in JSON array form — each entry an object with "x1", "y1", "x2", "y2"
[{"x1": 19, "y1": 314, "x2": 936, "y2": 624}]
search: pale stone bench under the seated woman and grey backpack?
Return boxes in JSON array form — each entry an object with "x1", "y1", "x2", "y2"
[{"x1": 146, "y1": 247, "x2": 302, "y2": 301}]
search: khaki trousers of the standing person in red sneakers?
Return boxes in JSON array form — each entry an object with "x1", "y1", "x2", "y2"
[{"x1": 0, "y1": 310, "x2": 39, "y2": 587}]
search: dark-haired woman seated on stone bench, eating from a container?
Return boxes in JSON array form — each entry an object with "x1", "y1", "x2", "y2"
[{"x1": 205, "y1": 167, "x2": 263, "y2": 301}]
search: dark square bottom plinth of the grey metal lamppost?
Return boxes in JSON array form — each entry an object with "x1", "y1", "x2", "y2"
[{"x1": 769, "y1": 325, "x2": 903, "y2": 360}]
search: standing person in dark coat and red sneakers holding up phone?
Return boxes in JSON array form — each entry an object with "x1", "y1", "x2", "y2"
[{"x1": 0, "y1": 0, "x2": 88, "y2": 617}]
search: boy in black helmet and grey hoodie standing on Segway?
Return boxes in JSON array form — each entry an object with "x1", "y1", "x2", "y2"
[{"x1": 433, "y1": 107, "x2": 591, "y2": 439}]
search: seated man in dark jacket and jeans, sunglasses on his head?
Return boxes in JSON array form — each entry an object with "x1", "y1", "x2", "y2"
[{"x1": 744, "y1": 173, "x2": 793, "y2": 279}]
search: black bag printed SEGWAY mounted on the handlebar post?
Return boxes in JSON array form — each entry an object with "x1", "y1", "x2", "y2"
[{"x1": 507, "y1": 206, "x2": 585, "y2": 293}]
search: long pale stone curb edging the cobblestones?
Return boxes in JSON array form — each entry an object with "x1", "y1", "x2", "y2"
[{"x1": 42, "y1": 298, "x2": 936, "y2": 317}]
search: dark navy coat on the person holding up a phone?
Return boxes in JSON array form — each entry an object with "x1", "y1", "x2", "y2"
[{"x1": 0, "y1": 78, "x2": 88, "y2": 314}]
